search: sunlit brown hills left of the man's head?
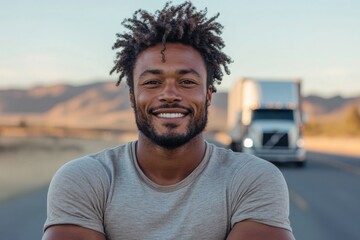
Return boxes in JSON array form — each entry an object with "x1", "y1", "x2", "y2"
[{"x1": 0, "y1": 82, "x2": 132, "y2": 128}]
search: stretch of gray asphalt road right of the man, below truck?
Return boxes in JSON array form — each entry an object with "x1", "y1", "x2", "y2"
[{"x1": 279, "y1": 152, "x2": 360, "y2": 240}]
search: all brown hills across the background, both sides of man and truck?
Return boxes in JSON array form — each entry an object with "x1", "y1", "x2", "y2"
[{"x1": 0, "y1": 82, "x2": 360, "y2": 129}]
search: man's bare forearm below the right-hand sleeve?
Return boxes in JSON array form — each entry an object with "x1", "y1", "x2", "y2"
[{"x1": 227, "y1": 220, "x2": 295, "y2": 240}]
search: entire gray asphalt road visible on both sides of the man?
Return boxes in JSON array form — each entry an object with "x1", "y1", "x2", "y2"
[{"x1": 0, "y1": 152, "x2": 360, "y2": 240}]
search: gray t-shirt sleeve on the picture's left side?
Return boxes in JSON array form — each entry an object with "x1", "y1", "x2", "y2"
[{"x1": 44, "y1": 157, "x2": 110, "y2": 233}]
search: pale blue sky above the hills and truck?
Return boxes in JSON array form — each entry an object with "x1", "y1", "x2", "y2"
[{"x1": 0, "y1": 0, "x2": 360, "y2": 97}]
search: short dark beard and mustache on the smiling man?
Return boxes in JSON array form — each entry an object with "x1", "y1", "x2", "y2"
[{"x1": 134, "y1": 100, "x2": 208, "y2": 150}]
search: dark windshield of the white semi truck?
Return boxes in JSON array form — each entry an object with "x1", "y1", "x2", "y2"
[{"x1": 252, "y1": 109, "x2": 294, "y2": 121}]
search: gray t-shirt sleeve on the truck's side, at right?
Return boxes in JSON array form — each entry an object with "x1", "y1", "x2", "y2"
[{"x1": 231, "y1": 158, "x2": 291, "y2": 231}]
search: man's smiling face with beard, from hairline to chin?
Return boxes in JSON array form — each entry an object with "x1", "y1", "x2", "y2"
[{"x1": 130, "y1": 43, "x2": 211, "y2": 149}]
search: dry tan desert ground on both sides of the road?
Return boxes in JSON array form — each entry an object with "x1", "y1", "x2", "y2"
[{"x1": 0, "y1": 134, "x2": 360, "y2": 201}]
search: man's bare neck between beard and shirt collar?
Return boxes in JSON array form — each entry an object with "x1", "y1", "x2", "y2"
[{"x1": 136, "y1": 133, "x2": 206, "y2": 185}]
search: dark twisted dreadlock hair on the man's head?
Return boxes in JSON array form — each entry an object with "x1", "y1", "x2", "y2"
[{"x1": 110, "y1": 2, "x2": 232, "y2": 92}]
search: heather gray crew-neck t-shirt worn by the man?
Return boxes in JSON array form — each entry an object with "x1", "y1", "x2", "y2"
[{"x1": 44, "y1": 142, "x2": 291, "y2": 240}]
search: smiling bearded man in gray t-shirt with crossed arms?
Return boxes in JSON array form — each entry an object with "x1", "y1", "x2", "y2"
[{"x1": 43, "y1": 2, "x2": 293, "y2": 240}]
